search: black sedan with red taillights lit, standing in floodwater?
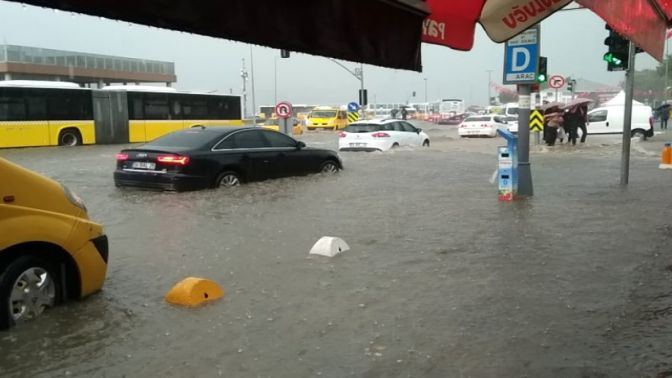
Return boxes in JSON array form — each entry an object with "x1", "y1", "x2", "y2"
[{"x1": 114, "y1": 127, "x2": 343, "y2": 191}]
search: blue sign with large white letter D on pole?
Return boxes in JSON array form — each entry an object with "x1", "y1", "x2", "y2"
[{"x1": 504, "y1": 26, "x2": 539, "y2": 84}]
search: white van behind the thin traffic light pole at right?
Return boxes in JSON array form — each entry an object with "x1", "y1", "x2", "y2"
[{"x1": 588, "y1": 105, "x2": 653, "y2": 139}]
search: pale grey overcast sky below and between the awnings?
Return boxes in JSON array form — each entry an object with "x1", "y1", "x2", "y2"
[{"x1": 0, "y1": 1, "x2": 656, "y2": 106}]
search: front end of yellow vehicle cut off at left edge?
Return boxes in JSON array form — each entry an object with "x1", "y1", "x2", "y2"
[{"x1": 0, "y1": 158, "x2": 108, "y2": 329}]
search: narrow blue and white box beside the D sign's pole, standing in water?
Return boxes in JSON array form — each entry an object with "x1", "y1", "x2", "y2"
[{"x1": 497, "y1": 130, "x2": 518, "y2": 201}]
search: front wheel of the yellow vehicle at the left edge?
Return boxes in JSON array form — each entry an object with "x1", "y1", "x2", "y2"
[{"x1": 0, "y1": 256, "x2": 61, "y2": 329}]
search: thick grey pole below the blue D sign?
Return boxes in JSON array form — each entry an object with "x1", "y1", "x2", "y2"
[{"x1": 518, "y1": 84, "x2": 534, "y2": 196}]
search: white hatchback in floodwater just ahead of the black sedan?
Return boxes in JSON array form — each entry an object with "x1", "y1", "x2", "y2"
[{"x1": 338, "y1": 119, "x2": 429, "y2": 151}]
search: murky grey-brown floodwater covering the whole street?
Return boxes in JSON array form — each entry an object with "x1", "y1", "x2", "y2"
[{"x1": 0, "y1": 124, "x2": 672, "y2": 377}]
